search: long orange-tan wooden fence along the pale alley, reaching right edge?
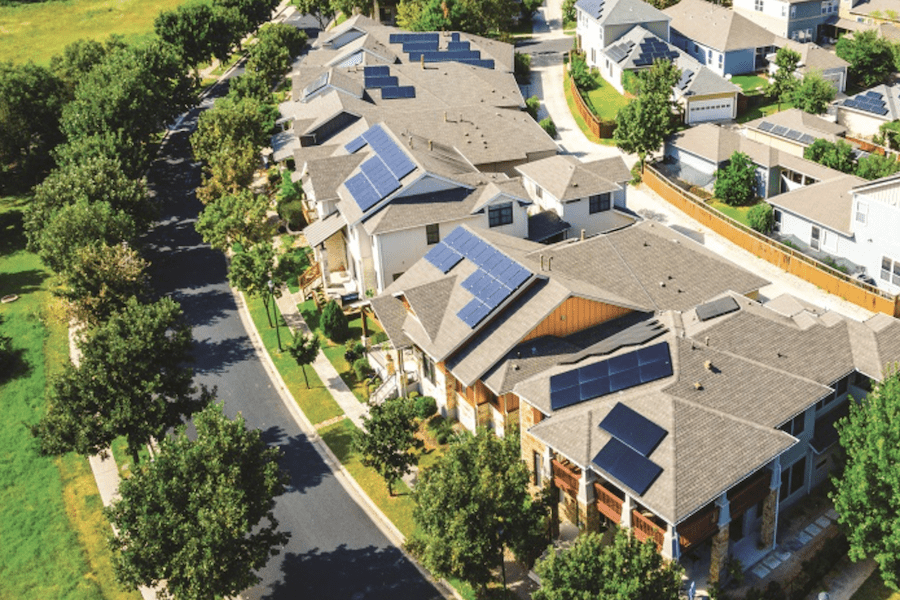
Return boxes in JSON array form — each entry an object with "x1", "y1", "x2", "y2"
[{"x1": 644, "y1": 164, "x2": 900, "y2": 317}]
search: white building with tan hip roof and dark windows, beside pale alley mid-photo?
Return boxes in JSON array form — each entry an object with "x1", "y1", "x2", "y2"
[{"x1": 516, "y1": 155, "x2": 634, "y2": 242}]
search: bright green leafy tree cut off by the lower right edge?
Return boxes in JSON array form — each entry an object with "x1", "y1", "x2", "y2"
[{"x1": 829, "y1": 365, "x2": 900, "y2": 590}]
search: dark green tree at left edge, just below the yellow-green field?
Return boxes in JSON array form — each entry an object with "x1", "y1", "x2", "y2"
[{"x1": 0, "y1": 62, "x2": 66, "y2": 171}]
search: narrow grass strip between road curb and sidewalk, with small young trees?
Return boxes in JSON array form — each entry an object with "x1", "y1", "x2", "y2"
[{"x1": 245, "y1": 295, "x2": 344, "y2": 425}]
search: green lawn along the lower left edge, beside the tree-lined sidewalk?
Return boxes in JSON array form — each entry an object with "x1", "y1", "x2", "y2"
[{"x1": 0, "y1": 198, "x2": 140, "y2": 600}]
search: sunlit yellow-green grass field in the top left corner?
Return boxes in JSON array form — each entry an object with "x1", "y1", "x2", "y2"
[{"x1": 0, "y1": 0, "x2": 196, "y2": 65}]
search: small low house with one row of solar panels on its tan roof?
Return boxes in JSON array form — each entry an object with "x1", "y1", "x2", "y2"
[{"x1": 741, "y1": 108, "x2": 847, "y2": 158}]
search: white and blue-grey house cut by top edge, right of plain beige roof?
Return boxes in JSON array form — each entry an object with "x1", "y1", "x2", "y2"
[{"x1": 732, "y1": 0, "x2": 838, "y2": 42}]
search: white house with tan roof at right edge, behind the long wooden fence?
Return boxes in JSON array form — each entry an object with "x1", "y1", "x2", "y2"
[{"x1": 770, "y1": 170, "x2": 900, "y2": 294}]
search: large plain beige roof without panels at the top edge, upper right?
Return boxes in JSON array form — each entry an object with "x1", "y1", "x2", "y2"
[{"x1": 662, "y1": 0, "x2": 781, "y2": 52}]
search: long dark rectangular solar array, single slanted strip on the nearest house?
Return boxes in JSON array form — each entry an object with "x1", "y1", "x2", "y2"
[{"x1": 550, "y1": 342, "x2": 672, "y2": 410}]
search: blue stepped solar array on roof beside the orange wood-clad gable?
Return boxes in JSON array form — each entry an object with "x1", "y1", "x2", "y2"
[{"x1": 425, "y1": 227, "x2": 532, "y2": 328}]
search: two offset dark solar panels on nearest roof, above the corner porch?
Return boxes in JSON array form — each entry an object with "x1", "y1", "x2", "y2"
[{"x1": 593, "y1": 402, "x2": 669, "y2": 496}]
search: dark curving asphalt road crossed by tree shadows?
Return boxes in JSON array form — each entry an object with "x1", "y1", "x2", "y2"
[{"x1": 147, "y1": 74, "x2": 443, "y2": 600}]
